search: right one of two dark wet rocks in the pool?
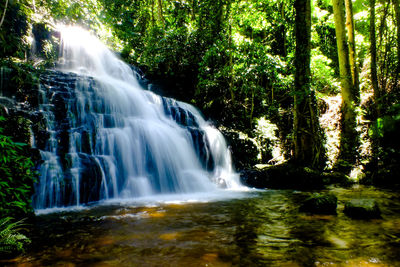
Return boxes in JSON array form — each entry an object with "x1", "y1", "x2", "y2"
[{"x1": 343, "y1": 199, "x2": 381, "y2": 219}]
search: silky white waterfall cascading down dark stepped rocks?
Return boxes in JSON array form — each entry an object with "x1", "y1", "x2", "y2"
[{"x1": 33, "y1": 27, "x2": 240, "y2": 209}]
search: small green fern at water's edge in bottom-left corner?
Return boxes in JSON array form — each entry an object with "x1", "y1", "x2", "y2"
[{"x1": 0, "y1": 217, "x2": 31, "y2": 254}]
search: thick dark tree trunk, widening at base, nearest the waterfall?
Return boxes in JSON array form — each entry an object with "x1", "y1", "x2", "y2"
[{"x1": 293, "y1": 0, "x2": 323, "y2": 167}]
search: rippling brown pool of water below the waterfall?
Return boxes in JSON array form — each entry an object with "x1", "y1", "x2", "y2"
[{"x1": 4, "y1": 187, "x2": 400, "y2": 266}]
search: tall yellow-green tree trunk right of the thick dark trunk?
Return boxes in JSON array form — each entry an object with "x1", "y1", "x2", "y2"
[{"x1": 332, "y1": 0, "x2": 357, "y2": 171}]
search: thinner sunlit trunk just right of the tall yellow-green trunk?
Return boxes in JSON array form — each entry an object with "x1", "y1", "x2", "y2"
[{"x1": 345, "y1": 0, "x2": 360, "y2": 103}]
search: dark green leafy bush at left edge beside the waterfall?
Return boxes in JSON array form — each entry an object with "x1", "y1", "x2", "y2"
[{"x1": 0, "y1": 117, "x2": 37, "y2": 217}]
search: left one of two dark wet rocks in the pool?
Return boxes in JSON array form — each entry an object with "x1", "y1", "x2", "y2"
[{"x1": 299, "y1": 193, "x2": 337, "y2": 214}]
